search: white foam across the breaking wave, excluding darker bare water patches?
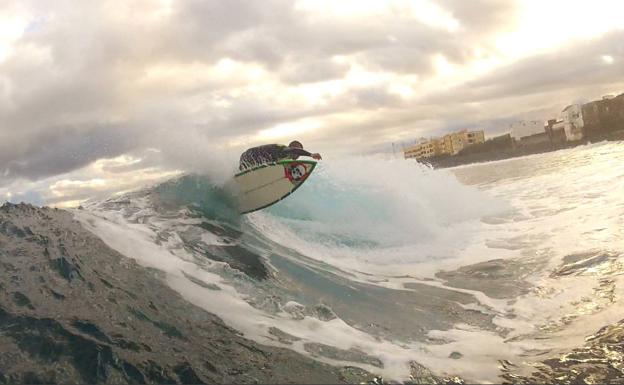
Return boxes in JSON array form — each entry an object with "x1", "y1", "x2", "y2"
[{"x1": 76, "y1": 143, "x2": 624, "y2": 382}]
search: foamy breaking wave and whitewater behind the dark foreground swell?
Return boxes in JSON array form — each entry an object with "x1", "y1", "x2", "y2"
[{"x1": 74, "y1": 142, "x2": 624, "y2": 382}]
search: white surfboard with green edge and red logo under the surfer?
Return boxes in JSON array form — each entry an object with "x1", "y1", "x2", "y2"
[{"x1": 232, "y1": 160, "x2": 316, "y2": 214}]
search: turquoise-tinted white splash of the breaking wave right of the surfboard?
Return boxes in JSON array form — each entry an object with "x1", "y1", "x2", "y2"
[{"x1": 247, "y1": 154, "x2": 509, "y2": 277}]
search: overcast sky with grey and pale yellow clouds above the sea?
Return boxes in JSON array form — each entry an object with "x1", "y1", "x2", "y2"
[{"x1": 0, "y1": 0, "x2": 624, "y2": 207}]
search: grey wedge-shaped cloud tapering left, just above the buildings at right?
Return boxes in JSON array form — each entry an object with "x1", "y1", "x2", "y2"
[{"x1": 424, "y1": 31, "x2": 624, "y2": 113}]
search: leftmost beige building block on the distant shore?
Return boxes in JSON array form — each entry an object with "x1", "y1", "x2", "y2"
[{"x1": 403, "y1": 130, "x2": 485, "y2": 159}]
